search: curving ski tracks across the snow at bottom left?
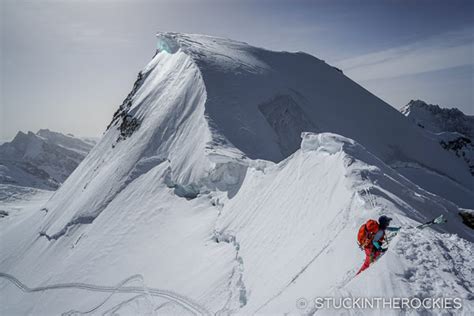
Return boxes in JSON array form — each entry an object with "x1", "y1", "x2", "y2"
[{"x1": 0, "y1": 272, "x2": 212, "y2": 315}]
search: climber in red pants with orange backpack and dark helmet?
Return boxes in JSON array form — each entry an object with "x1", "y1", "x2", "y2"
[{"x1": 357, "y1": 215, "x2": 400, "y2": 274}]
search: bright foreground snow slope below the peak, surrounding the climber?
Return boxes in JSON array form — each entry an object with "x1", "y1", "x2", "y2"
[{"x1": 0, "y1": 134, "x2": 474, "y2": 315}]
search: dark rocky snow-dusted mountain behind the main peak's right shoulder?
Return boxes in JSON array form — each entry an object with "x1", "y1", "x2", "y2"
[{"x1": 400, "y1": 100, "x2": 474, "y2": 183}]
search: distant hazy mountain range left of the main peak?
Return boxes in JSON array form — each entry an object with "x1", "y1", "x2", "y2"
[{"x1": 0, "y1": 129, "x2": 95, "y2": 190}]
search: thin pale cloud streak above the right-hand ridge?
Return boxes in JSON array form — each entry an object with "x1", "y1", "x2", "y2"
[{"x1": 335, "y1": 28, "x2": 474, "y2": 81}]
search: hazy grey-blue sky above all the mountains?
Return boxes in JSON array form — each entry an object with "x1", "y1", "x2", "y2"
[{"x1": 0, "y1": 0, "x2": 474, "y2": 141}]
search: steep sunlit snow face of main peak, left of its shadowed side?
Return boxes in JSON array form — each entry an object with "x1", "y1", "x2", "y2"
[{"x1": 39, "y1": 48, "x2": 210, "y2": 237}]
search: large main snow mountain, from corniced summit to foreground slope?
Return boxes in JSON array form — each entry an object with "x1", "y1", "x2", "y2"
[{"x1": 0, "y1": 33, "x2": 474, "y2": 315}]
